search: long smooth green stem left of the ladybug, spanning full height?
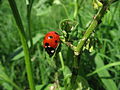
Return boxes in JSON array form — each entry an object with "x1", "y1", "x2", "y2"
[{"x1": 8, "y1": 0, "x2": 35, "y2": 90}]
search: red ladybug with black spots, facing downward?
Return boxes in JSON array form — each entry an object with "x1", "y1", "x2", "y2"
[{"x1": 43, "y1": 31, "x2": 60, "y2": 56}]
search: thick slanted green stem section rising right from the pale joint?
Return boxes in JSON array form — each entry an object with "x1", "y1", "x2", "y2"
[{"x1": 75, "y1": 2, "x2": 108, "y2": 55}]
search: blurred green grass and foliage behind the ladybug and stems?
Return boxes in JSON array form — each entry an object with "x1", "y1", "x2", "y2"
[{"x1": 0, "y1": 0, "x2": 120, "y2": 90}]
